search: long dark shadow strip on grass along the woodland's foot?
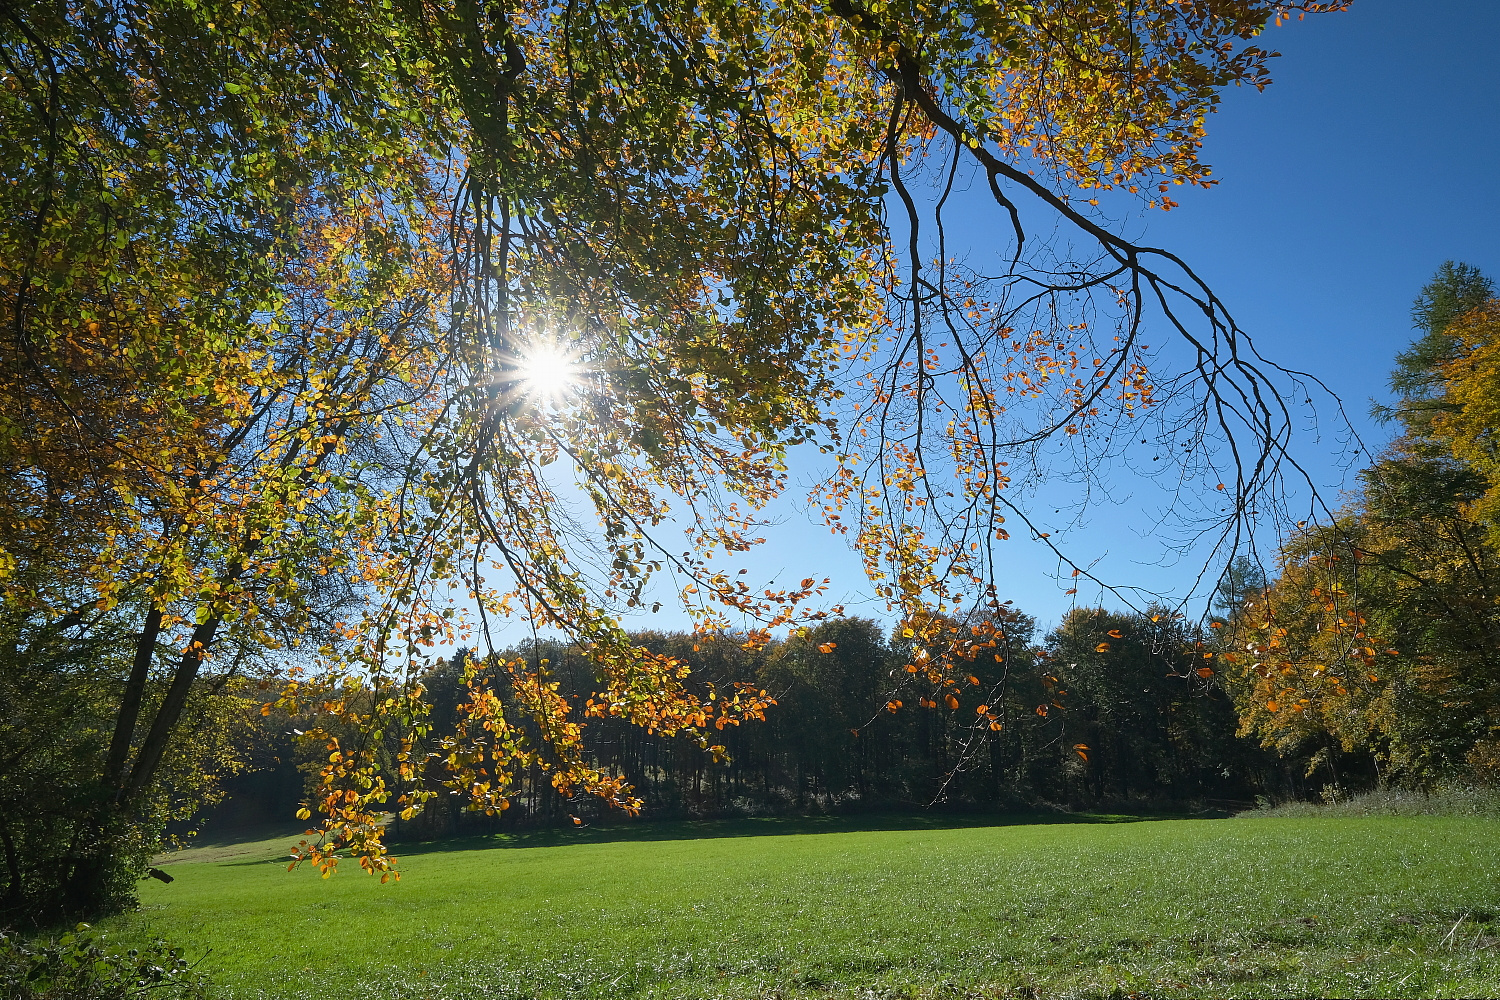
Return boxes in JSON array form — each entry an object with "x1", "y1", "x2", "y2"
[{"x1": 378, "y1": 810, "x2": 1230, "y2": 858}]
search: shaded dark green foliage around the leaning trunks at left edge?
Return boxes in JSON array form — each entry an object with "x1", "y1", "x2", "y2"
[{"x1": 0, "y1": 575, "x2": 248, "y2": 921}]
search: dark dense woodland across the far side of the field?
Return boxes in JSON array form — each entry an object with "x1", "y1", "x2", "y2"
[{"x1": 219, "y1": 609, "x2": 1314, "y2": 837}]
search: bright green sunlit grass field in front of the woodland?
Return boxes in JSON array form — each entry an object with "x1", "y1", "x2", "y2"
[{"x1": 101, "y1": 817, "x2": 1500, "y2": 1000}]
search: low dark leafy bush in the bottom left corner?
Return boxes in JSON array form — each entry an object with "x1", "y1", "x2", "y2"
[{"x1": 0, "y1": 924, "x2": 207, "y2": 1000}]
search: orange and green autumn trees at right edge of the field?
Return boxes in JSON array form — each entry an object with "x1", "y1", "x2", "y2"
[{"x1": 1227, "y1": 262, "x2": 1500, "y2": 783}]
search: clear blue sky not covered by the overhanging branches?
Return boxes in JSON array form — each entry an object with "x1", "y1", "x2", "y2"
[{"x1": 507, "y1": 0, "x2": 1500, "y2": 650}]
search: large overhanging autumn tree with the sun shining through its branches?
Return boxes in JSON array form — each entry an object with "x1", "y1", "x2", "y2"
[{"x1": 0, "y1": 0, "x2": 1344, "y2": 917}]
